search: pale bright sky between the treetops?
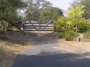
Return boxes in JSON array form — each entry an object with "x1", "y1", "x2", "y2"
[{"x1": 47, "y1": 0, "x2": 75, "y2": 11}]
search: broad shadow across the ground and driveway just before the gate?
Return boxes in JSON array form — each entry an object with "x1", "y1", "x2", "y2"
[{"x1": 0, "y1": 32, "x2": 56, "y2": 45}]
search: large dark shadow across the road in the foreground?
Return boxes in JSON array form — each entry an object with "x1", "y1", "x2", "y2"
[{"x1": 12, "y1": 52, "x2": 90, "y2": 67}]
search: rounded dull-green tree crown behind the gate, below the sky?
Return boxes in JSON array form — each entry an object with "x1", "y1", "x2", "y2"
[{"x1": 40, "y1": 7, "x2": 63, "y2": 20}]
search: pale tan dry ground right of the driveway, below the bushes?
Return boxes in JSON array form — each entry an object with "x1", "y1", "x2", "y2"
[{"x1": 54, "y1": 41, "x2": 90, "y2": 53}]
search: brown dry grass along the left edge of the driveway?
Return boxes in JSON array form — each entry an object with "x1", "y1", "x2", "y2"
[{"x1": 0, "y1": 41, "x2": 30, "y2": 67}]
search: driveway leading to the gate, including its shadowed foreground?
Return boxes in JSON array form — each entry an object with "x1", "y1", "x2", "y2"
[{"x1": 12, "y1": 32, "x2": 90, "y2": 67}]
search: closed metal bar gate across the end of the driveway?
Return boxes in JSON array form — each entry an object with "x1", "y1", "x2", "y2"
[{"x1": 23, "y1": 20, "x2": 54, "y2": 32}]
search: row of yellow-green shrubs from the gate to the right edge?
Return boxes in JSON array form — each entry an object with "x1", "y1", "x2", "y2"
[{"x1": 54, "y1": 17, "x2": 90, "y2": 33}]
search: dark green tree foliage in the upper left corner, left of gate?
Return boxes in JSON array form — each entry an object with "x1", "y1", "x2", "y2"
[{"x1": 0, "y1": 0, "x2": 25, "y2": 31}]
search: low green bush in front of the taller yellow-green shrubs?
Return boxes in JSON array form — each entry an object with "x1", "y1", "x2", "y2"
[{"x1": 59, "y1": 31, "x2": 78, "y2": 41}]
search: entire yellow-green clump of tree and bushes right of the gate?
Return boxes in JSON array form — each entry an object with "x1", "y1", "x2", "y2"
[{"x1": 54, "y1": 5, "x2": 90, "y2": 40}]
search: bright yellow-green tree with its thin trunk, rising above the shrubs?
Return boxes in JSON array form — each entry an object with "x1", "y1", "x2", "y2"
[{"x1": 67, "y1": 4, "x2": 85, "y2": 32}]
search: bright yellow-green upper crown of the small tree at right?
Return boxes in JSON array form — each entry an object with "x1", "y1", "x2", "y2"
[{"x1": 67, "y1": 4, "x2": 85, "y2": 19}]
